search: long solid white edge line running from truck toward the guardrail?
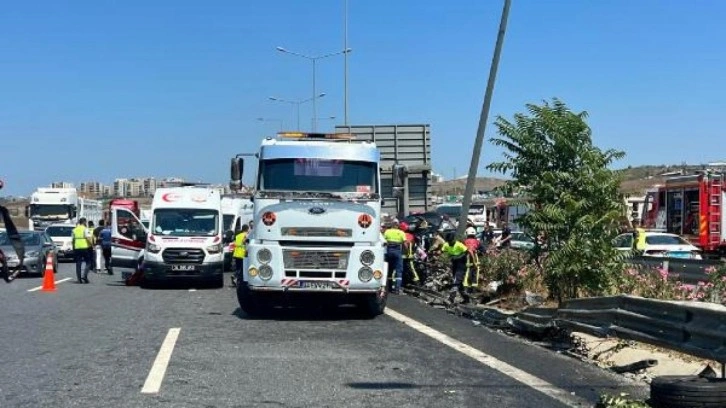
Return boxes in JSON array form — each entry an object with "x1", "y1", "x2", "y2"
[{"x1": 385, "y1": 308, "x2": 592, "y2": 407}]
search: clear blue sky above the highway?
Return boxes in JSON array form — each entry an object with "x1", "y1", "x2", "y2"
[{"x1": 0, "y1": 0, "x2": 726, "y2": 194}]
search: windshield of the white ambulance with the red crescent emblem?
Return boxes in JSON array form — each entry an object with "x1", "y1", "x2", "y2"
[{"x1": 152, "y1": 208, "x2": 219, "y2": 237}]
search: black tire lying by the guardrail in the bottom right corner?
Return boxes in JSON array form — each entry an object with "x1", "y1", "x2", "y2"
[{"x1": 650, "y1": 375, "x2": 726, "y2": 408}]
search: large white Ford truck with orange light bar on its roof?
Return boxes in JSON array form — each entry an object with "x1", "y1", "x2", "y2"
[{"x1": 230, "y1": 132, "x2": 388, "y2": 317}]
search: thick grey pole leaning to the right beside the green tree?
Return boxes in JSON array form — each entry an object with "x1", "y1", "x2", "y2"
[{"x1": 456, "y1": 0, "x2": 511, "y2": 237}]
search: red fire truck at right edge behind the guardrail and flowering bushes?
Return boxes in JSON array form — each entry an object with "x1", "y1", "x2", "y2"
[{"x1": 641, "y1": 171, "x2": 726, "y2": 256}]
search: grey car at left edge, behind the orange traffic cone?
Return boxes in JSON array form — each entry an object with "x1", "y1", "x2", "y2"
[{"x1": 0, "y1": 231, "x2": 58, "y2": 276}]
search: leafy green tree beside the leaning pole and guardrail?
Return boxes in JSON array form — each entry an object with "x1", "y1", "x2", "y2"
[{"x1": 488, "y1": 98, "x2": 624, "y2": 302}]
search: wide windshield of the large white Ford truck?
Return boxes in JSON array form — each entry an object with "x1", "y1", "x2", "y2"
[{"x1": 260, "y1": 159, "x2": 378, "y2": 194}]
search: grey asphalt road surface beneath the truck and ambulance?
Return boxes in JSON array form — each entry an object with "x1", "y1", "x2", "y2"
[{"x1": 0, "y1": 264, "x2": 645, "y2": 408}]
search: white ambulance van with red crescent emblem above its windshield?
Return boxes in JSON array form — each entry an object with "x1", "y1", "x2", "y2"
[{"x1": 142, "y1": 187, "x2": 225, "y2": 286}]
